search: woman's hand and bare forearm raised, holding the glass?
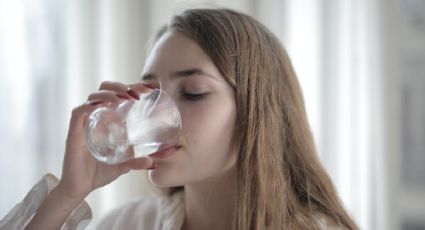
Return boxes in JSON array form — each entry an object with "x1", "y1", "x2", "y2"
[{"x1": 26, "y1": 82, "x2": 154, "y2": 229}]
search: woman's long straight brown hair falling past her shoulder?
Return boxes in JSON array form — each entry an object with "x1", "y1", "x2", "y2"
[{"x1": 154, "y1": 9, "x2": 357, "y2": 229}]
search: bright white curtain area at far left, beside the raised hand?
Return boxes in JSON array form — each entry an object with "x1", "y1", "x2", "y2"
[{"x1": 0, "y1": 0, "x2": 70, "y2": 221}]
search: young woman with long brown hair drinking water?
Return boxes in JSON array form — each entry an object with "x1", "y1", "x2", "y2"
[{"x1": 1, "y1": 9, "x2": 357, "y2": 229}]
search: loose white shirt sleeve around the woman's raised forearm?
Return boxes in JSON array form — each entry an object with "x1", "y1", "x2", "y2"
[{"x1": 0, "y1": 174, "x2": 92, "y2": 230}]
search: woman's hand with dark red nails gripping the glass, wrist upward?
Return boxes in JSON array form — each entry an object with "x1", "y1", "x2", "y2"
[{"x1": 57, "y1": 82, "x2": 153, "y2": 199}]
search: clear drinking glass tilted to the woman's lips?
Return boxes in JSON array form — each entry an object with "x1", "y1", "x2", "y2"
[{"x1": 86, "y1": 89, "x2": 181, "y2": 164}]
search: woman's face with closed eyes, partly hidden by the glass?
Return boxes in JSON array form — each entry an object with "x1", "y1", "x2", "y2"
[{"x1": 142, "y1": 32, "x2": 236, "y2": 187}]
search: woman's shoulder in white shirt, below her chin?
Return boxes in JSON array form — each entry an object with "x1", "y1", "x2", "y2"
[{"x1": 97, "y1": 193, "x2": 184, "y2": 229}]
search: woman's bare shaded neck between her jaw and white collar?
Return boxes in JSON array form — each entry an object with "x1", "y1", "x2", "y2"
[{"x1": 183, "y1": 168, "x2": 237, "y2": 230}]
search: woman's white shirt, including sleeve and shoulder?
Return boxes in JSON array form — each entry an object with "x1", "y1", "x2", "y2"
[{"x1": 0, "y1": 174, "x2": 185, "y2": 230}]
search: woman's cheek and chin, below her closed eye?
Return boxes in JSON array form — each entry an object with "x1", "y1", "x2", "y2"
[{"x1": 149, "y1": 94, "x2": 236, "y2": 187}]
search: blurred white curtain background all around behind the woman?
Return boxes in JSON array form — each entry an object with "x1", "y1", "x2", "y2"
[{"x1": 0, "y1": 0, "x2": 425, "y2": 230}]
